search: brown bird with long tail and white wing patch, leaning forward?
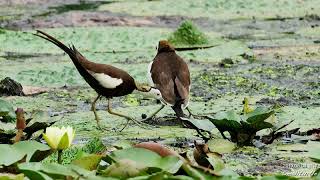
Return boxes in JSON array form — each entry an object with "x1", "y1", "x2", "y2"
[{"x1": 35, "y1": 30, "x2": 152, "y2": 128}]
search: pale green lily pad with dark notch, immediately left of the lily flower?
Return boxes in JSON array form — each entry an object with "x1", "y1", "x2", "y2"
[{"x1": 12, "y1": 141, "x2": 51, "y2": 162}]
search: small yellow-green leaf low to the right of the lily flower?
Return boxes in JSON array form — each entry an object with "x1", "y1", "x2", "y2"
[{"x1": 72, "y1": 154, "x2": 102, "y2": 171}]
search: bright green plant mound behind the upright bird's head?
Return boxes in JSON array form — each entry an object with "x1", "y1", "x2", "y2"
[{"x1": 168, "y1": 21, "x2": 209, "y2": 46}]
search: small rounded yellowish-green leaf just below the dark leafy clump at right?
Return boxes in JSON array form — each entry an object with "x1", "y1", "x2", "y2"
[{"x1": 207, "y1": 139, "x2": 236, "y2": 154}]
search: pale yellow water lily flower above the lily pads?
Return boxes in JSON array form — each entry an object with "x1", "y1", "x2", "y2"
[{"x1": 43, "y1": 126, "x2": 75, "y2": 150}]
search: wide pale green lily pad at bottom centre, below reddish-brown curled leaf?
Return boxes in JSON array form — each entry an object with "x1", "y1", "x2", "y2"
[{"x1": 109, "y1": 148, "x2": 183, "y2": 174}]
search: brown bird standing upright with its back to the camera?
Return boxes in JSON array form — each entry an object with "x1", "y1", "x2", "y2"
[{"x1": 148, "y1": 40, "x2": 191, "y2": 118}]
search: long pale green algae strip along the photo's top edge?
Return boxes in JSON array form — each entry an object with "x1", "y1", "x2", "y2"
[{"x1": 99, "y1": 0, "x2": 319, "y2": 20}]
